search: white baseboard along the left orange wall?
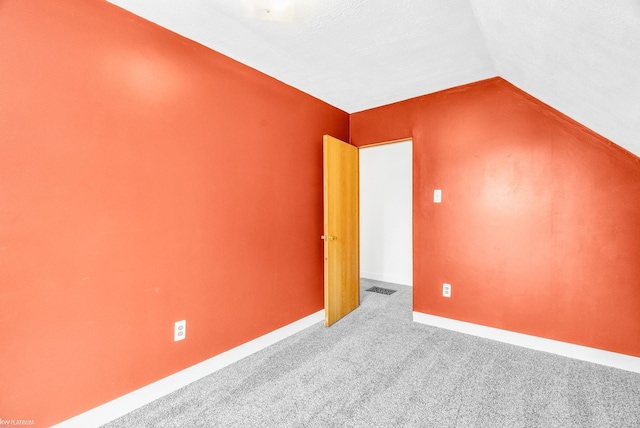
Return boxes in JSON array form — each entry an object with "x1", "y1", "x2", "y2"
[{"x1": 52, "y1": 309, "x2": 324, "y2": 428}]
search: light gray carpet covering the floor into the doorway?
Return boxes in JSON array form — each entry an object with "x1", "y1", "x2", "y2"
[{"x1": 105, "y1": 280, "x2": 640, "y2": 428}]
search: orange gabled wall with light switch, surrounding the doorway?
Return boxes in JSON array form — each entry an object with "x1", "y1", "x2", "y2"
[{"x1": 351, "y1": 78, "x2": 640, "y2": 356}]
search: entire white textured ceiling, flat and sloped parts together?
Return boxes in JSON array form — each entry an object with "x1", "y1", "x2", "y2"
[{"x1": 108, "y1": 0, "x2": 640, "y2": 155}]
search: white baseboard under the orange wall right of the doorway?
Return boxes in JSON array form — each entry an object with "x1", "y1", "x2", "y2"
[{"x1": 413, "y1": 312, "x2": 640, "y2": 373}]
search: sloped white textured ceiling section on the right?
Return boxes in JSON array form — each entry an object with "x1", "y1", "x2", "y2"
[{"x1": 471, "y1": 0, "x2": 640, "y2": 155}]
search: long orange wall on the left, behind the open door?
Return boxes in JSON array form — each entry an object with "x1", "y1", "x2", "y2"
[{"x1": 0, "y1": 0, "x2": 349, "y2": 426}]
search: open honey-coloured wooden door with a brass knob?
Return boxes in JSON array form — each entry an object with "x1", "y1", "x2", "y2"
[{"x1": 323, "y1": 135, "x2": 360, "y2": 326}]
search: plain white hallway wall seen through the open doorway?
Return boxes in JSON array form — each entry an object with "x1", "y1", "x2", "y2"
[{"x1": 360, "y1": 141, "x2": 413, "y2": 285}]
